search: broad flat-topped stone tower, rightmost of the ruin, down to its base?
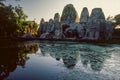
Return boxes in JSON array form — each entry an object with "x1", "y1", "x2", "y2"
[{"x1": 84, "y1": 8, "x2": 106, "y2": 40}]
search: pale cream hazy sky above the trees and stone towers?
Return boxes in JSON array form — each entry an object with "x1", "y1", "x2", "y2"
[{"x1": 5, "y1": 0, "x2": 120, "y2": 23}]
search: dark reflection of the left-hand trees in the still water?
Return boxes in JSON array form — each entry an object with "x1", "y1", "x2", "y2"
[{"x1": 0, "y1": 44, "x2": 38, "y2": 80}]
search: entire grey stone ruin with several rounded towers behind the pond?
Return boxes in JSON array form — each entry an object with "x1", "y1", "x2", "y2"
[{"x1": 38, "y1": 4, "x2": 114, "y2": 40}]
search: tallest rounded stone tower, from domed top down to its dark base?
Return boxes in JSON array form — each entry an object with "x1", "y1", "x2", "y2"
[{"x1": 61, "y1": 4, "x2": 79, "y2": 38}]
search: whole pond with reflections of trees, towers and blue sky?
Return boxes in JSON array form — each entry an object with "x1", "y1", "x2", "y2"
[{"x1": 0, "y1": 41, "x2": 120, "y2": 80}]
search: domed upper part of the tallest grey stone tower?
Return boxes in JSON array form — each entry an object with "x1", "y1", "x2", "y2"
[{"x1": 61, "y1": 4, "x2": 79, "y2": 25}]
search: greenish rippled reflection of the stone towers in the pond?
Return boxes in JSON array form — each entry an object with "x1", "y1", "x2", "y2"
[{"x1": 41, "y1": 44, "x2": 110, "y2": 71}]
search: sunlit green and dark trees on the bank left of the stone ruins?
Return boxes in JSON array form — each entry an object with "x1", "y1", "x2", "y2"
[{"x1": 0, "y1": 2, "x2": 38, "y2": 37}]
